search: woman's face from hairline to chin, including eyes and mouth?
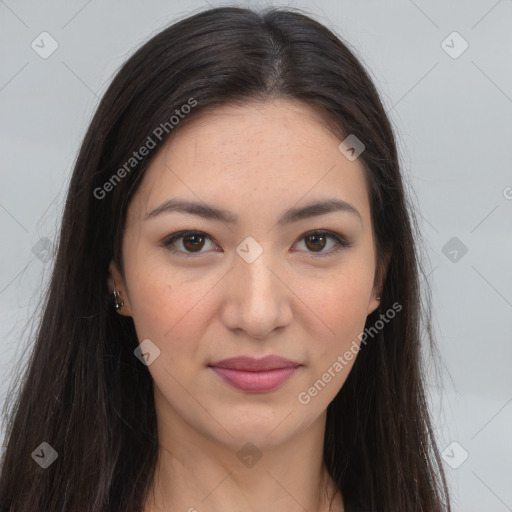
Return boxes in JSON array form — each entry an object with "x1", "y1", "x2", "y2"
[{"x1": 111, "y1": 100, "x2": 384, "y2": 449}]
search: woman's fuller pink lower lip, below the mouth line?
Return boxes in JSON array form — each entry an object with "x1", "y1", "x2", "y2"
[{"x1": 211, "y1": 366, "x2": 298, "y2": 393}]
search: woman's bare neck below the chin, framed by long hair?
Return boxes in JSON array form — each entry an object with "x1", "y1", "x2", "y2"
[{"x1": 144, "y1": 390, "x2": 344, "y2": 512}]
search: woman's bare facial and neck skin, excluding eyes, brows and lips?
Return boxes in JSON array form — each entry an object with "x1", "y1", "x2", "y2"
[{"x1": 109, "y1": 100, "x2": 379, "y2": 512}]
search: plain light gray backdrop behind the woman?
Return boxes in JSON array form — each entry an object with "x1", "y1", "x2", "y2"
[{"x1": 0, "y1": 0, "x2": 512, "y2": 512}]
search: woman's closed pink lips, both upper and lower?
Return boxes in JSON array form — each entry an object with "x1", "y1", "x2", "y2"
[{"x1": 210, "y1": 356, "x2": 301, "y2": 393}]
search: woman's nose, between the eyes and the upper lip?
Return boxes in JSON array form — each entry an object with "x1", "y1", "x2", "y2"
[{"x1": 221, "y1": 251, "x2": 293, "y2": 339}]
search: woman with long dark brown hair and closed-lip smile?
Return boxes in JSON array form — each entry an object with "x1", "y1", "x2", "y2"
[{"x1": 0, "y1": 7, "x2": 450, "y2": 512}]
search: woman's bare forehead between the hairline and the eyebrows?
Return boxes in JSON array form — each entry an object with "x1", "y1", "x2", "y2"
[{"x1": 128, "y1": 100, "x2": 369, "y2": 226}]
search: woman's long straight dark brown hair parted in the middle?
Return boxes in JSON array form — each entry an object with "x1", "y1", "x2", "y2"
[{"x1": 0, "y1": 7, "x2": 450, "y2": 512}]
